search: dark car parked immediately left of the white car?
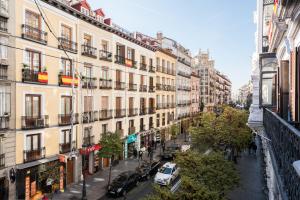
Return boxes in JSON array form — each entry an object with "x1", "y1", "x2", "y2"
[{"x1": 136, "y1": 161, "x2": 161, "y2": 180}]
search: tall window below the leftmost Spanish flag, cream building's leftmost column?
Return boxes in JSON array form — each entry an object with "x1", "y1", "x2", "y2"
[{"x1": 25, "y1": 94, "x2": 41, "y2": 117}]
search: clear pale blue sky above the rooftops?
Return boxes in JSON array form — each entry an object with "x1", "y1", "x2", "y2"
[{"x1": 88, "y1": 0, "x2": 256, "y2": 90}]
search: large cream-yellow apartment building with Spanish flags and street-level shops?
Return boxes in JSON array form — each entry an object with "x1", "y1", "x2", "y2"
[{"x1": 9, "y1": 0, "x2": 156, "y2": 199}]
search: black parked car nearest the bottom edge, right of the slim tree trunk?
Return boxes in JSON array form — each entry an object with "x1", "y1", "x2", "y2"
[{"x1": 108, "y1": 171, "x2": 140, "y2": 196}]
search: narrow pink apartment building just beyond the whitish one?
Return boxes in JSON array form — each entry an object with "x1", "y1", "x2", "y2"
[{"x1": 190, "y1": 70, "x2": 200, "y2": 116}]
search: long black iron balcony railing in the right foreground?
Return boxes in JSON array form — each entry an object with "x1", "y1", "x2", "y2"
[{"x1": 263, "y1": 109, "x2": 300, "y2": 199}]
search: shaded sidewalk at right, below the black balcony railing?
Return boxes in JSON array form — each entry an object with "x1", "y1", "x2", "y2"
[{"x1": 228, "y1": 140, "x2": 267, "y2": 200}]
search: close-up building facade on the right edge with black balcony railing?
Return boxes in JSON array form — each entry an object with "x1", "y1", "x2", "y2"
[{"x1": 248, "y1": 0, "x2": 300, "y2": 200}]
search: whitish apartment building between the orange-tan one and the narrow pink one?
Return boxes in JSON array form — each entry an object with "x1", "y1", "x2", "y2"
[{"x1": 157, "y1": 33, "x2": 192, "y2": 133}]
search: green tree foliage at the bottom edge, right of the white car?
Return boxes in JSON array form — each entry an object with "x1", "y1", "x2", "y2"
[{"x1": 147, "y1": 151, "x2": 239, "y2": 200}]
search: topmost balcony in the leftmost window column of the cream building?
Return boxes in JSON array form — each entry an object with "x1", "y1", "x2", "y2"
[{"x1": 22, "y1": 24, "x2": 48, "y2": 44}]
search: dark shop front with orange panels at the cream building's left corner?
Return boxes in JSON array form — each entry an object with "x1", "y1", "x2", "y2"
[{"x1": 16, "y1": 157, "x2": 66, "y2": 200}]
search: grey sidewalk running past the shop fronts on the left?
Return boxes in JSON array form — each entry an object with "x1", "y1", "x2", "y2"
[{"x1": 53, "y1": 145, "x2": 160, "y2": 200}]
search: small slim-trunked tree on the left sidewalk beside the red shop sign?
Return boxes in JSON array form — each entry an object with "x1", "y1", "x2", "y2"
[{"x1": 98, "y1": 132, "x2": 122, "y2": 186}]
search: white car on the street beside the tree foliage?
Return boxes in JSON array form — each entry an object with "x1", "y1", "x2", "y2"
[{"x1": 154, "y1": 162, "x2": 180, "y2": 185}]
